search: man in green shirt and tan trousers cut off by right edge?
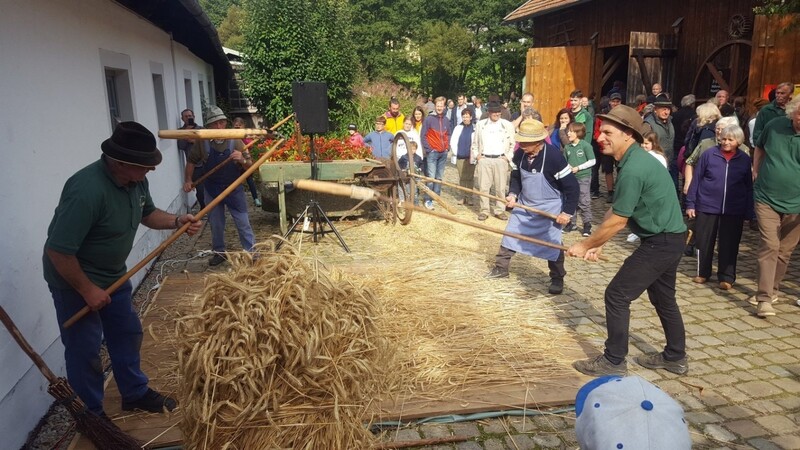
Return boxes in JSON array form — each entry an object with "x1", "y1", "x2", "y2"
[{"x1": 750, "y1": 97, "x2": 800, "y2": 317}]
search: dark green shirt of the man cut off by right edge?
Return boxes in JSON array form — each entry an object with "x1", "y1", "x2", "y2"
[{"x1": 753, "y1": 116, "x2": 800, "y2": 214}]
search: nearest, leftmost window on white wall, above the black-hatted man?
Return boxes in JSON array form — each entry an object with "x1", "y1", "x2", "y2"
[{"x1": 99, "y1": 48, "x2": 136, "y2": 130}]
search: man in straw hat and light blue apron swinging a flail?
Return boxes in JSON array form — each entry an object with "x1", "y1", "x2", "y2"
[{"x1": 489, "y1": 119, "x2": 580, "y2": 294}]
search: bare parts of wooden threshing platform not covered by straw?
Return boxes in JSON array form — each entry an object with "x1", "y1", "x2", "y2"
[{"x1": 70, "y1": 272, "x2": 590, "y2": 450}]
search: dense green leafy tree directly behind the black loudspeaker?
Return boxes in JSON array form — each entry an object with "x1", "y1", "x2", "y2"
[{"x1": 242, "y1": 0, "x2": 356, "y2": 128}]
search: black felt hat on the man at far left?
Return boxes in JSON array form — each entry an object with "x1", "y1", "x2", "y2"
[{"x1": 100, "y1": 122, "x2": 161, "y2": 167}]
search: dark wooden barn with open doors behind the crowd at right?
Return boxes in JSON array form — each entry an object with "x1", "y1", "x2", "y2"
[{"x1": 505, "y1": 0, "x2": 800, "y2": 121}]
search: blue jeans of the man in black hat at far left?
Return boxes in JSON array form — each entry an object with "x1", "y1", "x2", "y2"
[{"x1": 48, "y1": 281, "x2": 148, "y2": 414}]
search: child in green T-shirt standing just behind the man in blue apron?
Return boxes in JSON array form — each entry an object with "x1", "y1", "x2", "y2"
[{"x1": 564, "y1": 122, "x2": 596, "y2": 236}]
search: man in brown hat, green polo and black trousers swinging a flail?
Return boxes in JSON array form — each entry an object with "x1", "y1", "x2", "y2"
[{"x1": 567, "y1": 106, "x2": 689, "y2": 377}]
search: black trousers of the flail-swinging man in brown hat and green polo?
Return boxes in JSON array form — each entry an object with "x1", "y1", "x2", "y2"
[{"x1": 605, "y1": 233, "x2": 686, "y2": 364}]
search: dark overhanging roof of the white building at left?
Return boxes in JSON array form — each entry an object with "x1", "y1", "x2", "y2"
[{"x1": 115, "y1": 0, "x2": 232, "y2": 98}]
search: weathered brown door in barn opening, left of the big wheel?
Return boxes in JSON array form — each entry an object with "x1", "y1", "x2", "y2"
[{"x1": 625, "y1": 31, "x2": 677, "y2": 104}]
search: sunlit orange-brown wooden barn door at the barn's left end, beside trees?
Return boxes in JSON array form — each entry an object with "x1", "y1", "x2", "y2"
[{"x1": 525, "y1": 45, "x2": 596, "y2": 125}]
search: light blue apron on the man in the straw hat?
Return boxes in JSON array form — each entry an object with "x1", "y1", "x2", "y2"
[{"x1": 501, "y1": 145, "x2": 561, "y2": 261}]
